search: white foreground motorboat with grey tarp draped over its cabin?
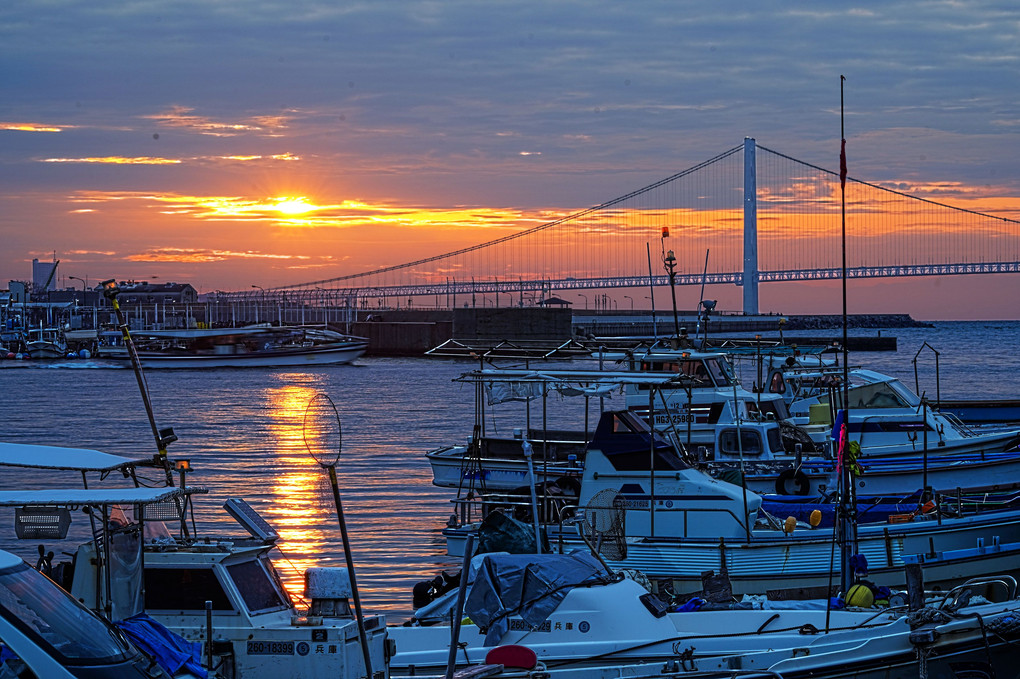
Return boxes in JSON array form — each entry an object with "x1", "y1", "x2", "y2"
[{"x1": 391, "y1": 553, "x2": 1020, "y2": 679}]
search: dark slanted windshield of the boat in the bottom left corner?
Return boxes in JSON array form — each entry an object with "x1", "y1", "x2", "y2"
[{"x1": 0, "y1": 562, "x2": 131, "y2": 665}]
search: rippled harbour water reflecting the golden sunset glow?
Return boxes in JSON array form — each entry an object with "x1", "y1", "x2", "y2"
[{"x1": 0, "y1": 321, "x2": 1020, "y2": 621}]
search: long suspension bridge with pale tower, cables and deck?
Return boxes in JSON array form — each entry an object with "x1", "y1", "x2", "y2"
[{"x1": 218, "y1": 139, "x2": 1020, "y2": 314}]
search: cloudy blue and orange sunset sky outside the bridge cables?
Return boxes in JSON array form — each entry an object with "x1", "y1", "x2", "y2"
[{"x1": 0, "y1": 0, "x2": 1020, "y2": 318}]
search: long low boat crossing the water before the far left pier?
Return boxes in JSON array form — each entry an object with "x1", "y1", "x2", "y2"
[{"x1": 98, "y1": 325, "x2": 368, "y2": 369}]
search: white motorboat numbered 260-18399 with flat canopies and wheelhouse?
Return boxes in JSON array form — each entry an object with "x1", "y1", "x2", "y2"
[{"x1": 0, "y1": 443, "x2": 389, "y2": 679}]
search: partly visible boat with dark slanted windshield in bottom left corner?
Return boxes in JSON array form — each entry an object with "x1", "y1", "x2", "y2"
[{"x1": 0, "y1": 551, "x2": 196, "y2": 679}]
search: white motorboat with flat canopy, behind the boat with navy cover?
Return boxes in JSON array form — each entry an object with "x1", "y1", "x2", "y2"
[{"x1": 426, "y1": 364, "x2": 1020, "y2": 497}]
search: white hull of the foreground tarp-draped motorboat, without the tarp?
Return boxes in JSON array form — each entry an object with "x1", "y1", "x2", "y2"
[{"x1": 390, "y1": 558, "x2": 1016, "y2": 679}]
